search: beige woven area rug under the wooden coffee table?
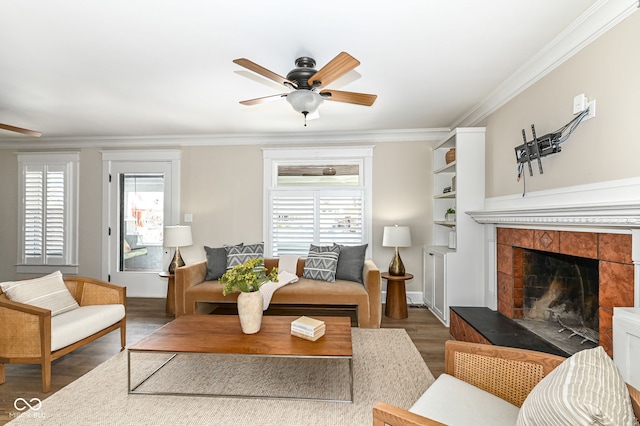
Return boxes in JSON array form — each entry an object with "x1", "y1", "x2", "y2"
[{"x1": 10, "y1": 328, "x2": 434, "y2": 426}]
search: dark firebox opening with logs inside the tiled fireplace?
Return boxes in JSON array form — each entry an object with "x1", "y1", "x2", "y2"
[{"x1": 516, "y1": 249, "x2": 600, "y2": 354}]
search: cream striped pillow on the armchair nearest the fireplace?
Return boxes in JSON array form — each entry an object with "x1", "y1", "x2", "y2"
[{"x1": 517, "y1": 346, "x2": 636, "y2": 426}]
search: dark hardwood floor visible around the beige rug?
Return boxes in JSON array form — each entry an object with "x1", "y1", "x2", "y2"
[{"x1": 0, "y1": 298, "x2": 450, "y2": 425}]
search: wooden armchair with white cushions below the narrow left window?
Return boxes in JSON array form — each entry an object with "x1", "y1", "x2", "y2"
[{"x1": 0, "y1": 272, "x2": 126, "y2": 392}]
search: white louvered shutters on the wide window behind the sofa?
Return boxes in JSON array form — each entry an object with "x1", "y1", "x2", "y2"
[{"x1": 271, "y1": 190, "x2": 364, "y2": 257}]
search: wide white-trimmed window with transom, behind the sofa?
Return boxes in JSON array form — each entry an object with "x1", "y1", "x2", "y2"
[{"x1": 264, "y1": 147, "x2": 373, "y2": 257}]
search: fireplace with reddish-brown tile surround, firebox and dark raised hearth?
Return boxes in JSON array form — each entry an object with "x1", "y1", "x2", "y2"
[{"x1": 451, "y1": 227, "x2": 635, "y2": 356}]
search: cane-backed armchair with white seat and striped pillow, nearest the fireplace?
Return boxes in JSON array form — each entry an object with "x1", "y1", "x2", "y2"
[{"x1": 373, "y1": 341, "x2": 640, "y2": 426}]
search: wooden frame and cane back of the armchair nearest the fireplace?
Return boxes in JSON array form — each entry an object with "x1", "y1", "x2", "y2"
[{"x1": 373, "y1": 340, "x2": 640, "y2": 426}]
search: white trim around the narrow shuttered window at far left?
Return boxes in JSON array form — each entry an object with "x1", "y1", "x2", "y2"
[{"x1": 16, "y1": 152, "x2": 80, "y2": 274}]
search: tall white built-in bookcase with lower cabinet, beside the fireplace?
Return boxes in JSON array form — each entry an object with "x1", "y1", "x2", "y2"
[{"x1": 422, "y1": 127, "x2": 485, "y2": 326}]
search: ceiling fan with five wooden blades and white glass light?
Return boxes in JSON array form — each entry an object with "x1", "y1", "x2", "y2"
[{"x1": 233, "y1": 52, "x2": 378, "y2": 126}]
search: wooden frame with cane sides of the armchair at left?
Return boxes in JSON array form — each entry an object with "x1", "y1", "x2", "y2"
[{"x1": 0, "y1": 276, "x2": 127, "y2": 392}]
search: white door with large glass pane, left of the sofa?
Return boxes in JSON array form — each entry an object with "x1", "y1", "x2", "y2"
[{"x1": 103, "y1": 161, "x2": 175, "y2": 297}]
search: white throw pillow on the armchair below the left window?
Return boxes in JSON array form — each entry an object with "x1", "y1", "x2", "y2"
[{"x1": 0, "y1": 271, "x2": 79, "y2": 316}]
